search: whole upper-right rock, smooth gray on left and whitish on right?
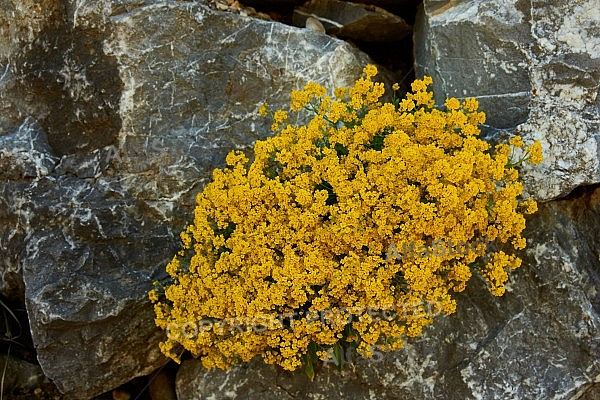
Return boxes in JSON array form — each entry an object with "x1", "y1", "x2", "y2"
[{"x1": 415, "y1": 0, "x2": 600, "y2": 200}]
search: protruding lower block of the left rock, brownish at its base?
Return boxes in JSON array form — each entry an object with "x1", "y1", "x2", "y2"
[{"x1": 21, "y1": 176, "x2": 175, "y2": 398}]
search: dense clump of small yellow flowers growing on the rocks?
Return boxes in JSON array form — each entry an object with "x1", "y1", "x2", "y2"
[{"x1": 150, "y1": 65, "x2": 541, "y2": 376}]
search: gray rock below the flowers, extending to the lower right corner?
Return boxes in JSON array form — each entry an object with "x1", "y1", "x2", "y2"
[{"x1": 177, "y1": 189, "x2": 600, "y2": 400}]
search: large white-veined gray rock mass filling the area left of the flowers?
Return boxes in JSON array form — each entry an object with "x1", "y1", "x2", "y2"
[{"x1": 0, "y1": 0, "x2": 376, "y2": 398}]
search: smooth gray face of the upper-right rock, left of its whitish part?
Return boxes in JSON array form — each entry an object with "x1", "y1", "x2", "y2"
[{"x1": 414, "y1": 0, "x2": 532, "y2": 128}]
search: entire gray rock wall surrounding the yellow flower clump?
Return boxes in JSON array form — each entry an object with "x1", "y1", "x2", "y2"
[{"x1": 0, "y1": 0, "x2": 600, "y2": 400}]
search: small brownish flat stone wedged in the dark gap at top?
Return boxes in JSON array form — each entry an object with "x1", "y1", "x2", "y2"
[{"x1": 294, "y1": 0, "x2": 412, "y2": 42}]
